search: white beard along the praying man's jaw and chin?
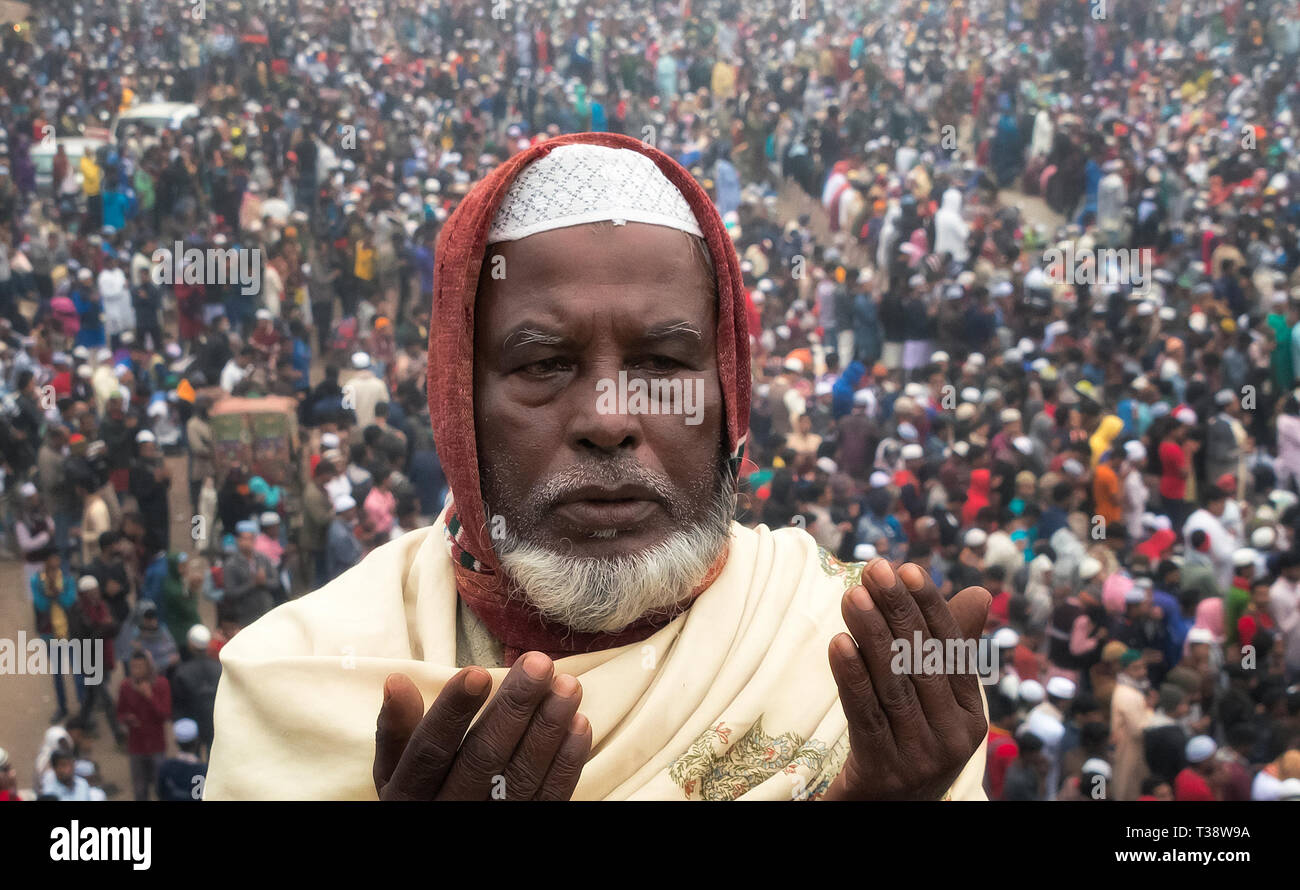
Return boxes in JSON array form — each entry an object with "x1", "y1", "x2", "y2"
[{"x1": 497, "y1": 486, "x2": 736, "y2": 633}]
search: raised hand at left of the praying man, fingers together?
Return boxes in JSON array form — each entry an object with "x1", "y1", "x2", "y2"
[{"x1": 373, "y1": 652, "x2": 592, "y2": 800}]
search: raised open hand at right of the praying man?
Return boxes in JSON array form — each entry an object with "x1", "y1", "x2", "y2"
[{"x1": 826, "y1": 559, "x2": 992, "y2": 800}]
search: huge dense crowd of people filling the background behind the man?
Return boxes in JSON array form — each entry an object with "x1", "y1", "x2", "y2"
[{"x1": 0, "y1": 0, "x2": 1300, "y2": 800}]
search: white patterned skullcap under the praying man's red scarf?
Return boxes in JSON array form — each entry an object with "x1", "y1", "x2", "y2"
[{"x1": 488, "y1": 144, "x2": 703, "y2": 244}]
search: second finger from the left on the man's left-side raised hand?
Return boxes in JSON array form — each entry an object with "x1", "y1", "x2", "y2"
[{"x1": 382, "y1": 668, "x2": 491, "y2": 800}]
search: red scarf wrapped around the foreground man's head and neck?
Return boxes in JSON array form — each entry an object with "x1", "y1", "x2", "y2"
[{"x1": 428, "y1": 133, "x2": 750, "y2": 661}]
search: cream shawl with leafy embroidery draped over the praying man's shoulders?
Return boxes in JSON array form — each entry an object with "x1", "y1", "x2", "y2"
[{"x1": 204, "y1": 520, "x2": 987, "y2": 800}]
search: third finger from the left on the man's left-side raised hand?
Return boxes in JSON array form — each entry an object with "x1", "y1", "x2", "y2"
[{"x1": 437, "y1": 652, "x2": 554, "y2": 800}]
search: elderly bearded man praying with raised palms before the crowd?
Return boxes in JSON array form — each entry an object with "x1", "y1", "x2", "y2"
[{"x1": 205, "y1": 134, "x2": 989, "y2": 800}]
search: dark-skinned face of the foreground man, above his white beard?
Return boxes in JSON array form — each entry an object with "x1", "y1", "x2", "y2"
[{"x1": 475, "y1": 223, "x2": 723, "y2": 556}]
